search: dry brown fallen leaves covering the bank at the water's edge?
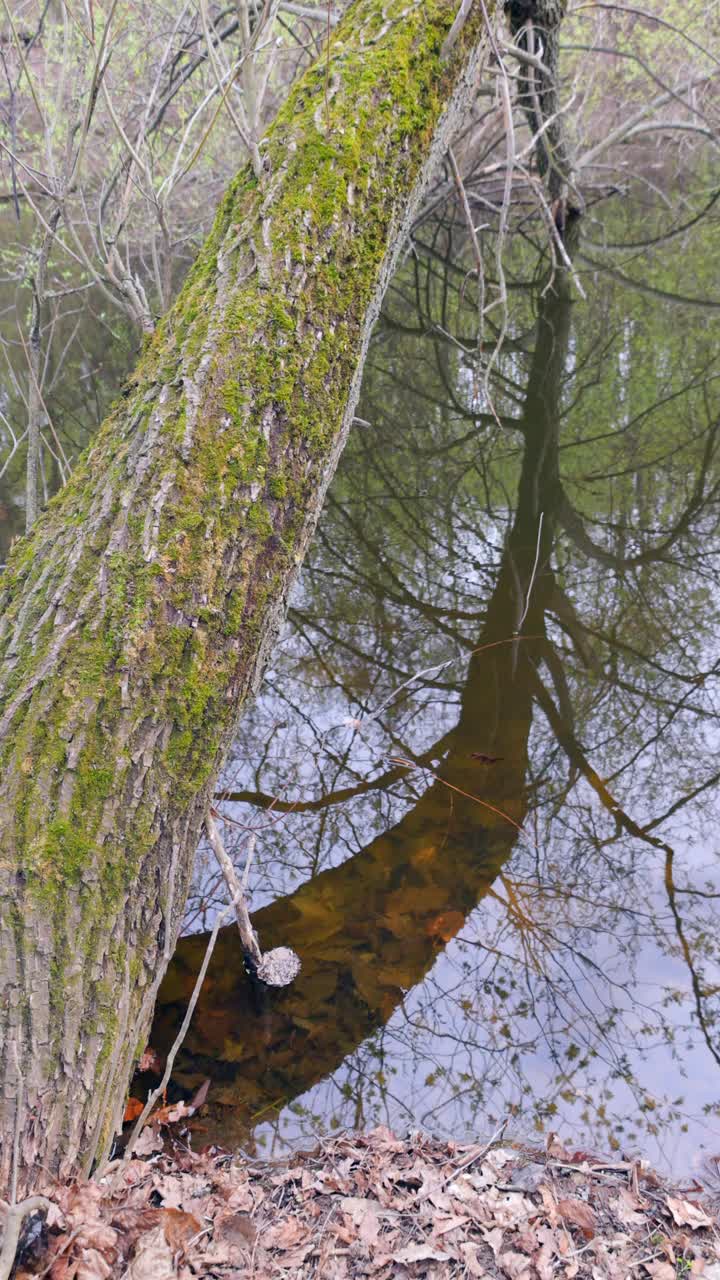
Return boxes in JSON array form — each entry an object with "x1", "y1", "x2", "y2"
[{"x1": 15, "y1": 1128, "x2": 720, "y2": 1280}]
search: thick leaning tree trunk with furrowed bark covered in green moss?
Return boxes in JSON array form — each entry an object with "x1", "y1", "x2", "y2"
[{"x1": 0, "y1": 0, "x2": 484, "y2": 1189}]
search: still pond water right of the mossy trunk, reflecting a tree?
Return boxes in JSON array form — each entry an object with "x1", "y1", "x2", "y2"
[{"x1": 154, "y1": 204, "x2": 719, "y2": 1172}]
